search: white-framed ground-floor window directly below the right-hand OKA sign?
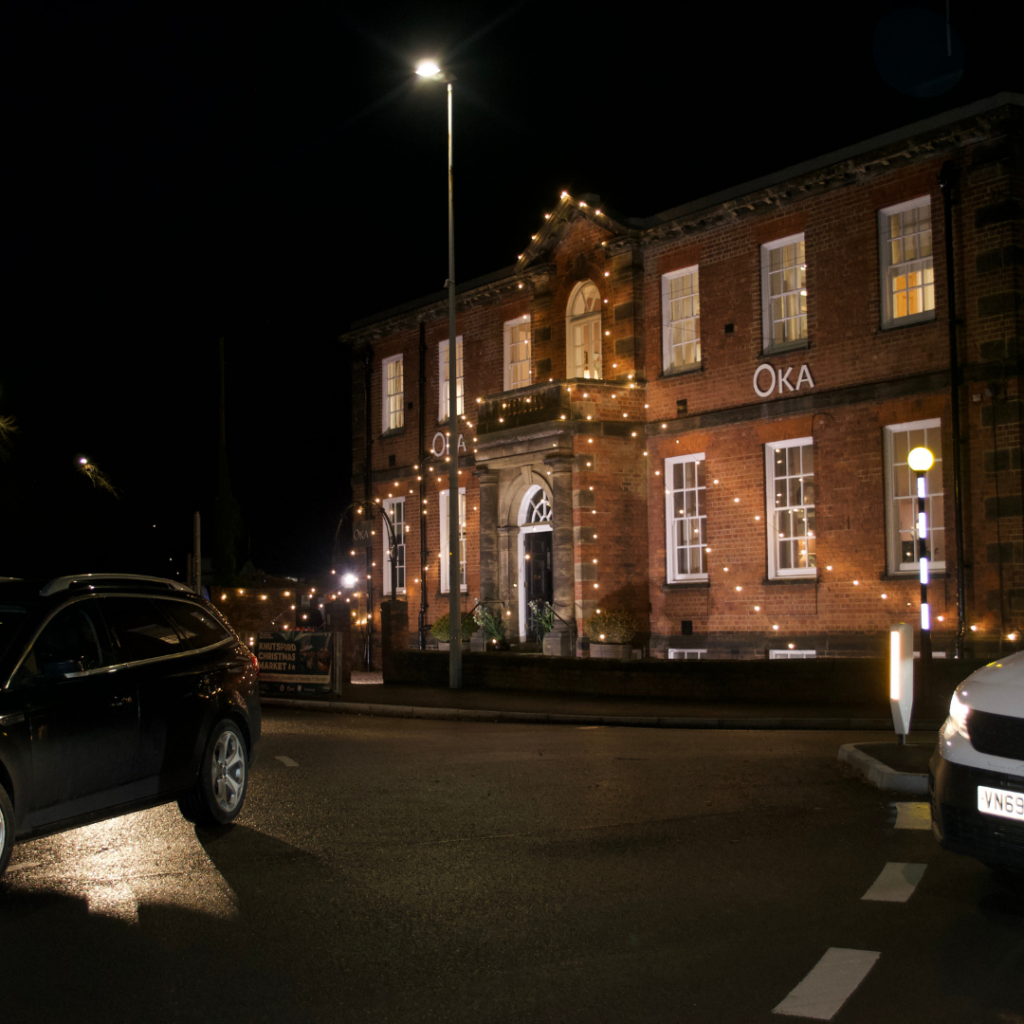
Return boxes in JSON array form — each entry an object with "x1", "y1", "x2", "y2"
[{"x1": 765, "y1": 437, "x2": 817, "y2": 580}]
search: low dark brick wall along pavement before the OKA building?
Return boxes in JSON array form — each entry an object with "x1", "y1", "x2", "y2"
[{"x1": 384, "y1": 649, "x2": 984, "y2": 719}]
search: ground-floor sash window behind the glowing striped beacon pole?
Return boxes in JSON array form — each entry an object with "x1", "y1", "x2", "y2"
[{"x1": 885, "y1": 420, "x2": 946, "y2": 575}]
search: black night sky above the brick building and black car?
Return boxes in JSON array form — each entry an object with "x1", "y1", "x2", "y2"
[{"x1": 0, "y1": 0, "x2": 1024, "y2": 575}]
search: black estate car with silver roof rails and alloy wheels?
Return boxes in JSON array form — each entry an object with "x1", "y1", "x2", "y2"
[{"x1": 0, "y1": 574, "x2": 260, "y2": 873}]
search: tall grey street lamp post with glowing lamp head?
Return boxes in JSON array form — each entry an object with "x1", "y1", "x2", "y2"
[{"x1": 416, "y1": 60, "x2": 462, "y2": 690}]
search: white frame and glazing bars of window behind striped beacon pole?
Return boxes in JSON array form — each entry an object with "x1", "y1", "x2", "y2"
[{"x1": 883, "y1": 419, "x2": 946, "y2": 577}]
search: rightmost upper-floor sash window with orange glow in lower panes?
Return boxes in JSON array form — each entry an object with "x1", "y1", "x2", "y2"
[{"x1": 879, "y1": 196, "x2": 935, "y2": 327}]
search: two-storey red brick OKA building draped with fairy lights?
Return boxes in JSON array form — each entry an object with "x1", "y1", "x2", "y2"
[{"x1": 341, "y1": 93, "x2": 1024, "y2": 657}]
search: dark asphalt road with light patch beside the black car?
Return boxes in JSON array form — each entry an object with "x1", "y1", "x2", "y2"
[{"x1": 0, "y1": 711, "x2": 1024, "y2": 1024}]
